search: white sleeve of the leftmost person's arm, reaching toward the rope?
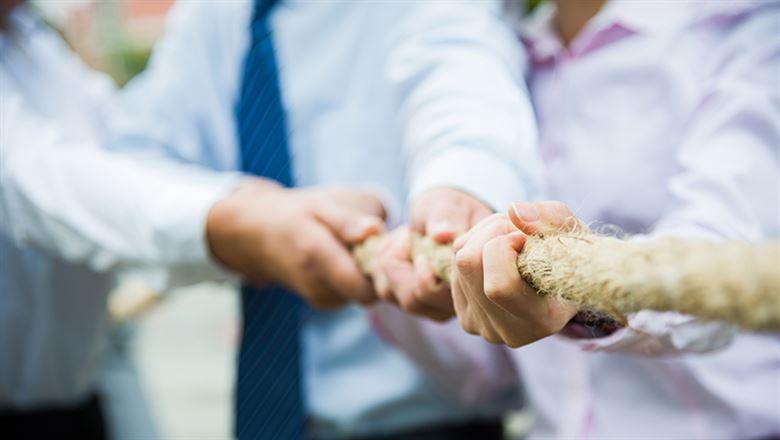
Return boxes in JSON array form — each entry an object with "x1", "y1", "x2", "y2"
[{"x1": 0, "y1": 90, "x2": 240, "y2": 283}]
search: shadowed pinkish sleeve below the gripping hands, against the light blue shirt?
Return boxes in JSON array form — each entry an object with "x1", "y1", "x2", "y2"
[{"x1": 370, "y1": 304, "x2": 520, "y2": 413}]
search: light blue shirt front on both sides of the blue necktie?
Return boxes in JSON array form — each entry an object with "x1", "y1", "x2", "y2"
[{"x1": 113, "y1": 0, "x2": 528, "y2": 436}]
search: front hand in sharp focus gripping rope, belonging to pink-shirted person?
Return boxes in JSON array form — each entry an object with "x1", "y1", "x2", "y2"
[{"x1": 452, "y1": 202, "x2": 581, "y2": 347}]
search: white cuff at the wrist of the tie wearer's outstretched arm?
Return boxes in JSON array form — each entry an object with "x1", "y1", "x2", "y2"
[{"x1": 409, "y1": 147, "x2": 529, "y2": 212}]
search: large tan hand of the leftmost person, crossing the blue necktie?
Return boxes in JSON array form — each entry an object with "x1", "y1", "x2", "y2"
[{"x1": 206, "y1": 179, "x2": 385, "y2": 309}]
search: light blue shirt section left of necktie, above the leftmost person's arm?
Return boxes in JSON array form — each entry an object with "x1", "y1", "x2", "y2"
[{"x1": 108, "y1": 0, "x2": 248, "y2": 170}]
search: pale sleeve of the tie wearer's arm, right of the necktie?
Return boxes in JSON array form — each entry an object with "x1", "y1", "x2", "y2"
[{"x1": 386, "y1": 1, "x2": 542, "y2": 211}]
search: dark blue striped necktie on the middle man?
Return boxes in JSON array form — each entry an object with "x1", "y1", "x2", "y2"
[{"x1": 236, "y1": 0, "x2": 305, "y2": 440}]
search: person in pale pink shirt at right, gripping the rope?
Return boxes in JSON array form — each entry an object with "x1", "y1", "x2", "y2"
[{"x1": 375, "y1": 0, "x2": 780, "y2": 439}]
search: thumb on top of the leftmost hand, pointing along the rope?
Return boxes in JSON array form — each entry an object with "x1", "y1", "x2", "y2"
[{"x1": 314, "y1": 202, "x2": 384, "y2": 245}]
